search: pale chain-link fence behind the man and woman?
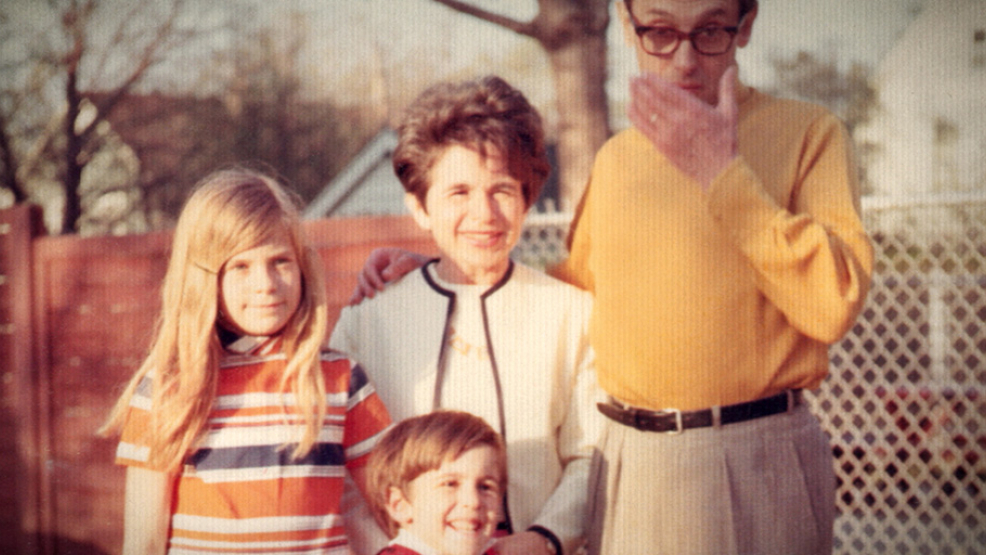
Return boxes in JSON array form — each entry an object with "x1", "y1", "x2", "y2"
[{"x1": 515, "y1": 195, "x2": 986, "y2": 555}]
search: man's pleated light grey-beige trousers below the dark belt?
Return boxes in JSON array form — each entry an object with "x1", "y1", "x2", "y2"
[{"x1": 589, "y1": 405, "x2": 835, "y2": 555}]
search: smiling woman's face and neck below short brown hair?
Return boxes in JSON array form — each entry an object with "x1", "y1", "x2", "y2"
[{"x1": 405, "y1": 145, "x2": 527, "y2": 285}]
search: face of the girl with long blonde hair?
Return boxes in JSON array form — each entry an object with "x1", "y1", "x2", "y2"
[{"x1": 219, "y1": 231, "x2": 302, "y2": 336}]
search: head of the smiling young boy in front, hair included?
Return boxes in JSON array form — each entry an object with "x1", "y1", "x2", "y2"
[{"x1": 367, "y1": 411, "x2": 507, "y2": 555}]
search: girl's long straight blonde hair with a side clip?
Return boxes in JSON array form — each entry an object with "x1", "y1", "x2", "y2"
[{"x1": 100, "y1": 168, "x2": 328, "y2": 471}]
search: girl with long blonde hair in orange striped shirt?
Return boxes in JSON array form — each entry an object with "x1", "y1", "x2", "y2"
[{"x1": 101, "y1": 169, "x2": 389, "y2": 554}]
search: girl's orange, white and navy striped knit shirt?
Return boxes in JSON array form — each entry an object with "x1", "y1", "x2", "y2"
[{"x1": 117, "y1": 337, "x2": 390, "y2": 555}]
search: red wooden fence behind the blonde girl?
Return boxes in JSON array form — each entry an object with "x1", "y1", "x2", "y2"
[{"x1": 0, "y1": 206, "x2": 434, "y2": 555}]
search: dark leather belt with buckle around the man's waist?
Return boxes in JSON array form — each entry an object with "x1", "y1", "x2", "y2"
[{"x1": 596, "y1": 389, "x2": 804, "y2": 434}]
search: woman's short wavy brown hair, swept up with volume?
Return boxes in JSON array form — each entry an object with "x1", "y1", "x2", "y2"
[{"x1": 393, "y1": 76, "x2": 551, "y2": 208}]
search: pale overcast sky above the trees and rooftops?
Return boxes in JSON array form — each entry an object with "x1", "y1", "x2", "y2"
[{"x1": 0, "y1": 0, "x2": 924, "y2": 122}]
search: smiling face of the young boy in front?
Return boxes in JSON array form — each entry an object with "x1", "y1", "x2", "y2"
[{"x1": 387, "y1": 446, "x2": 503, "y2": 555}]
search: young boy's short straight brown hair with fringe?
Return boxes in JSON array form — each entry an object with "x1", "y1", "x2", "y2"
[{"x1": 366, "y1": 410, "x2": 507, "y2": 538}]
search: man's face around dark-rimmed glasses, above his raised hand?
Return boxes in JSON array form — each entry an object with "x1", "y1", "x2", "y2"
[{"x1": 619, "y1": 0, "x2": 757, "y2": 105}]
